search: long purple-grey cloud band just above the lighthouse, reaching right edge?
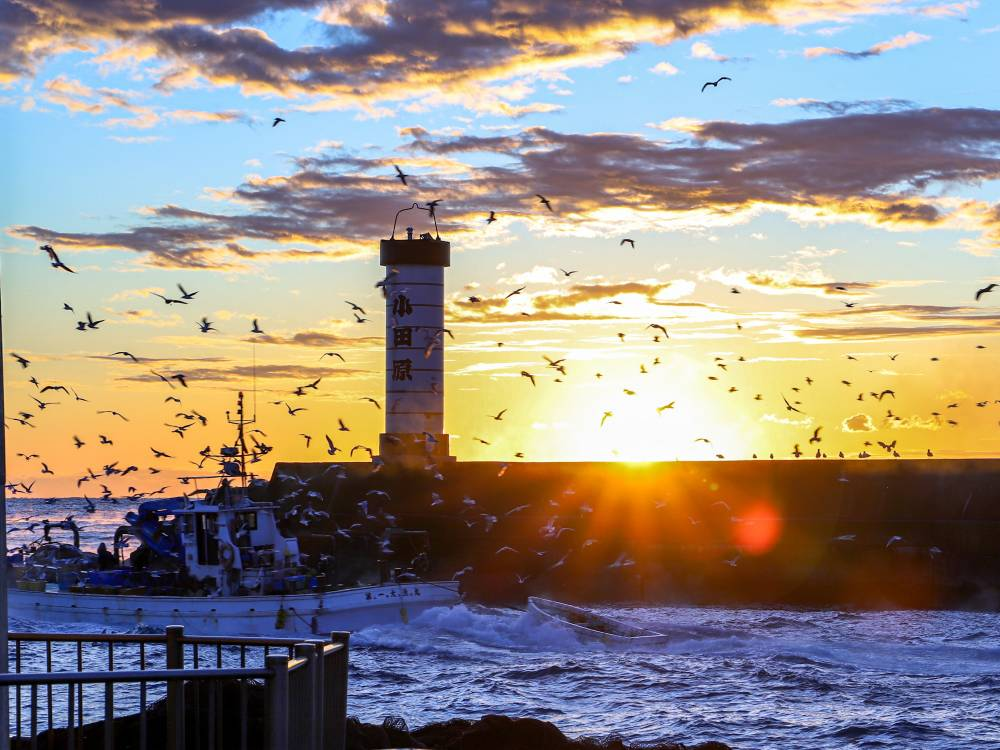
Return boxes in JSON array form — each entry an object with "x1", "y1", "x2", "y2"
[{"x1": 13, "y1": 108, "x2": 1000, "y2": 268}]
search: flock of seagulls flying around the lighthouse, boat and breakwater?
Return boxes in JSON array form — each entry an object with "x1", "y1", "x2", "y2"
[{"x1": 5, "y1": 131, "x2": 1000, "y2": 583}]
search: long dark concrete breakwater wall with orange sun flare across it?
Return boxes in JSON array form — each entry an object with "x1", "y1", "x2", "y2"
[{"x1": 270, "y1": 459, "x2": 1000, "y2": 609}]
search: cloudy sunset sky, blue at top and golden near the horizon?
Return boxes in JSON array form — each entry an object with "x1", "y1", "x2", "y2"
[{"x1": 0, "y1": 0, "x2": 1000, "y2": 496}]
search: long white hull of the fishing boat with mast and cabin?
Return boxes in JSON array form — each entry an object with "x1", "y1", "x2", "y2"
[{"x1": 7, "y1": 581, "x2": 461, "y2": 637}]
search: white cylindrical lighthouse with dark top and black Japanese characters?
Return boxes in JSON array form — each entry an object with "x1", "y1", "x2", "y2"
[{"x1": 379, "y1": 204, "x2": 451, "y2": 463}]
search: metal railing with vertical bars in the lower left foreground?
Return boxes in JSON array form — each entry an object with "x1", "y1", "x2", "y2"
[{"x1": 0, "y1": 625, "x2": 349, "y2": 750}]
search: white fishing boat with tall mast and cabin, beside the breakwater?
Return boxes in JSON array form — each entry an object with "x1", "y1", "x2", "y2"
[{"x1": 8, "y1": 393, "x2": 461, "y2": 636}]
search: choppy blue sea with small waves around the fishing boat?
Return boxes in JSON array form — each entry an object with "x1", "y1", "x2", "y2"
[{"x1": 8, "y1": 498, "x2": 1000, "y2": 750}]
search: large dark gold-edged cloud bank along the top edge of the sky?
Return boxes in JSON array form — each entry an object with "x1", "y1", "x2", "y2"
[{"x1": 0, "y1": 0, "x2": 916, "y2": 116}]
